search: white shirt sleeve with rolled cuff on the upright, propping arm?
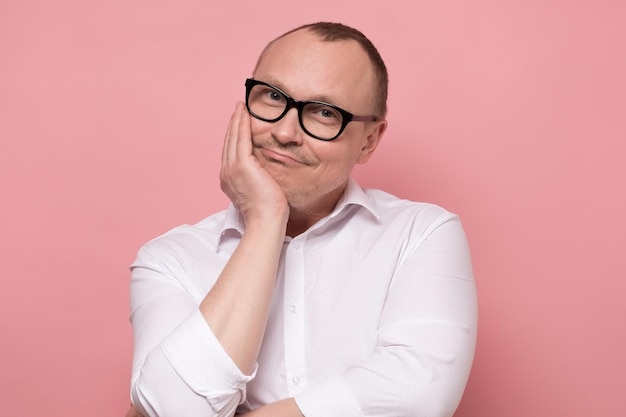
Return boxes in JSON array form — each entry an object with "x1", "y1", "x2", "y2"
[{"x1": 130, "y1": 240, "x2": 256, "y2": 417}]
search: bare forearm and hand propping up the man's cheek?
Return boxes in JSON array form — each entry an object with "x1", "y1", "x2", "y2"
[{"x1": 200, "y1": 103, "x2": 289, "y2": 374}]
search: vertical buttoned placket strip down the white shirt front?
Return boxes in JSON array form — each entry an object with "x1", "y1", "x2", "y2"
[{"x1": 283, "y1": 235, "x2": 306, "y2": 396}]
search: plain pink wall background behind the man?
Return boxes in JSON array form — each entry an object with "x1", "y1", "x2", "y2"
[{"x1": 0, "y1": 0, "x2": 626, "y2": 417}]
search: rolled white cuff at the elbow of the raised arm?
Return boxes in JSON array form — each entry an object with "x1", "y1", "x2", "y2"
[{"x1": 161, "y1": 309, "x2": 258, "y2": 409}]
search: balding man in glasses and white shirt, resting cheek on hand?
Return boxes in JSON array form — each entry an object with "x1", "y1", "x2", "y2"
[{"x1": 128, "y1": 23, "x2": 476, "y2": 417}]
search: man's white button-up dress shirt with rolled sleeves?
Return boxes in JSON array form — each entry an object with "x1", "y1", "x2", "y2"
[{"x1": 131, "y1": 180, "x2": 477, "y2": 417}]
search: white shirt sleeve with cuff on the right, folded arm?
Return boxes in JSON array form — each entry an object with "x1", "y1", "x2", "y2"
[{"x1": 295, "y1": 217, "x2": 477, "y2": 417}]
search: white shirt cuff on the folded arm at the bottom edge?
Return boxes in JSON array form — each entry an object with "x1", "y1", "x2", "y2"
[{"x1": 294, "y1": 378, "x2": 363, "y2": 417}]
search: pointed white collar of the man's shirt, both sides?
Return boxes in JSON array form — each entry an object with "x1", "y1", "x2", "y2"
[{"x1": 218, "y1": 178, "x2": 380, "y2": 244}]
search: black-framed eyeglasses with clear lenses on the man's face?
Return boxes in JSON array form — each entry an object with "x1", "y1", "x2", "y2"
[{"x1": 246, "y1": 78, "x2": 378, "y2": 141}]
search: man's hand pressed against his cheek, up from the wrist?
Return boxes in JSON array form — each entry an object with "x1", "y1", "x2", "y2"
[{"x1": 220, "y1": 102, "x2": 289, "y2": 226}]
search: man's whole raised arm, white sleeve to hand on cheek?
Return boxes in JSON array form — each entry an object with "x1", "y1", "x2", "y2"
[{"x1": 131, "y1": 103, "x2": 289, "y2": 417}]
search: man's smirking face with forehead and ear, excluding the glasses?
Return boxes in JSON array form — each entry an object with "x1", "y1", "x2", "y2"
[{"x1": 251, "y1": 30, "x2": 386, "y2": 211}]
